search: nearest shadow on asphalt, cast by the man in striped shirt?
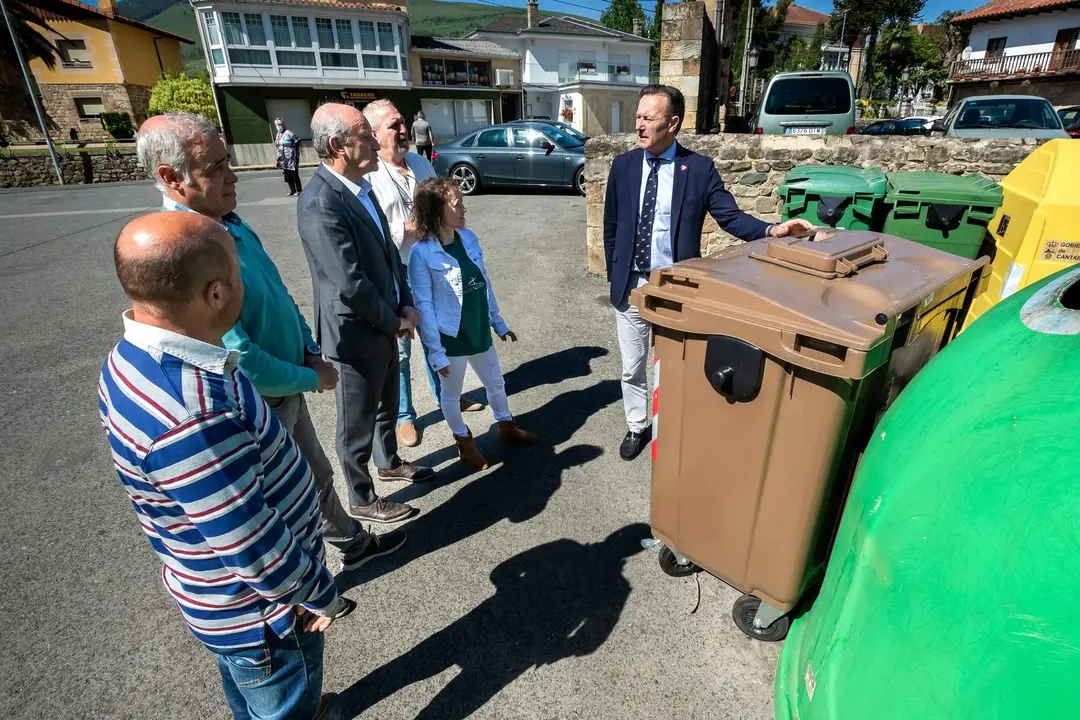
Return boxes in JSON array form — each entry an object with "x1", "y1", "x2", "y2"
[{"x1": 337, "y1": 522, "x2": 649, "y2": 720}]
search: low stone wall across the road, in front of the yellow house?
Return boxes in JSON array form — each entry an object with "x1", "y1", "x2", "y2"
[{"x1": 0, "y1": 151, "x2": 147, "y2": 188}]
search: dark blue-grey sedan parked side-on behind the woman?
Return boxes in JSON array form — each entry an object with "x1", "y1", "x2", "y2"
[{"x1": 433, "y1": 122, "x2": 585, "y2": 195}]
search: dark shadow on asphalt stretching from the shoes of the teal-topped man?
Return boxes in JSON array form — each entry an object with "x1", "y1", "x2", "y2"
[{"x1": 336, "y1": 380, "x2": 621, "y2": 593}]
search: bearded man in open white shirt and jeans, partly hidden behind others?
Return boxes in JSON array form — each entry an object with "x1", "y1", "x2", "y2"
[{"x1": 364, "y1": 99, "x2": 483, "y2": 448}]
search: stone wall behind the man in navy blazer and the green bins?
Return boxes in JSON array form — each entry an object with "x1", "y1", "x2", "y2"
[{"x1": 585, "y1": 135, "x2": 1039, "y2": 274}]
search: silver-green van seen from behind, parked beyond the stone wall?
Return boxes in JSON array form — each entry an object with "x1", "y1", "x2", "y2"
[{"x1": 754, "y1": 71, "x2": 855, "y2": 136}]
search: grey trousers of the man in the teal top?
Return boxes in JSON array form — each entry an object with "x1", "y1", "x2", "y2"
[{"x1": 266, "y1": 395, "x2": 372, "y2": 553}]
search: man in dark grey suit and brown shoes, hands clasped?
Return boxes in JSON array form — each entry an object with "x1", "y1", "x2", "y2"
[{"x1": 296, "y1": 104, "x2": 435, "y2": 522}]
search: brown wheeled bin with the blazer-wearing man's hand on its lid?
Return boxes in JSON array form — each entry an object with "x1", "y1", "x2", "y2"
[{"x1": 632, "y1": 230, "x2": 987, "y2": 640}]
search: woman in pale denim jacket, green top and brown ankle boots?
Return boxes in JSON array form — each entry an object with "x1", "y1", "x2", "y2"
[{"x1": 408, "y1": 178, "x2": 536, "y2": 470}]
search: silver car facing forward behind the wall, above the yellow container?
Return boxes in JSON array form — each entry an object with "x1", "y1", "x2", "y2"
[{"x1": 933, "y1": 95, "x2": 1069, "y2": 138}]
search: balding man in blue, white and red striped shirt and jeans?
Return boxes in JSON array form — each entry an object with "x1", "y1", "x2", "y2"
[{"x1": 98, "y1": 213, "x2": 355, "y2": 720}]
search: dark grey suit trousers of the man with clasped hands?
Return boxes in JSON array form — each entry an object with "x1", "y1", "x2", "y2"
[{"x1": 334, "y1": 338, "x2": 400, "y2": 505}]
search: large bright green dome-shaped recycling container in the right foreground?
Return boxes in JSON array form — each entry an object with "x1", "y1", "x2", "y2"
[{"x1": 773, "y1": 266, "x2": 1080, "y2": 720}]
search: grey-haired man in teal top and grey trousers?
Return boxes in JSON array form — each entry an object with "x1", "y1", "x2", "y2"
[{"x1": 137, "y1": 112, "x2": 405, "y2": 571}]
